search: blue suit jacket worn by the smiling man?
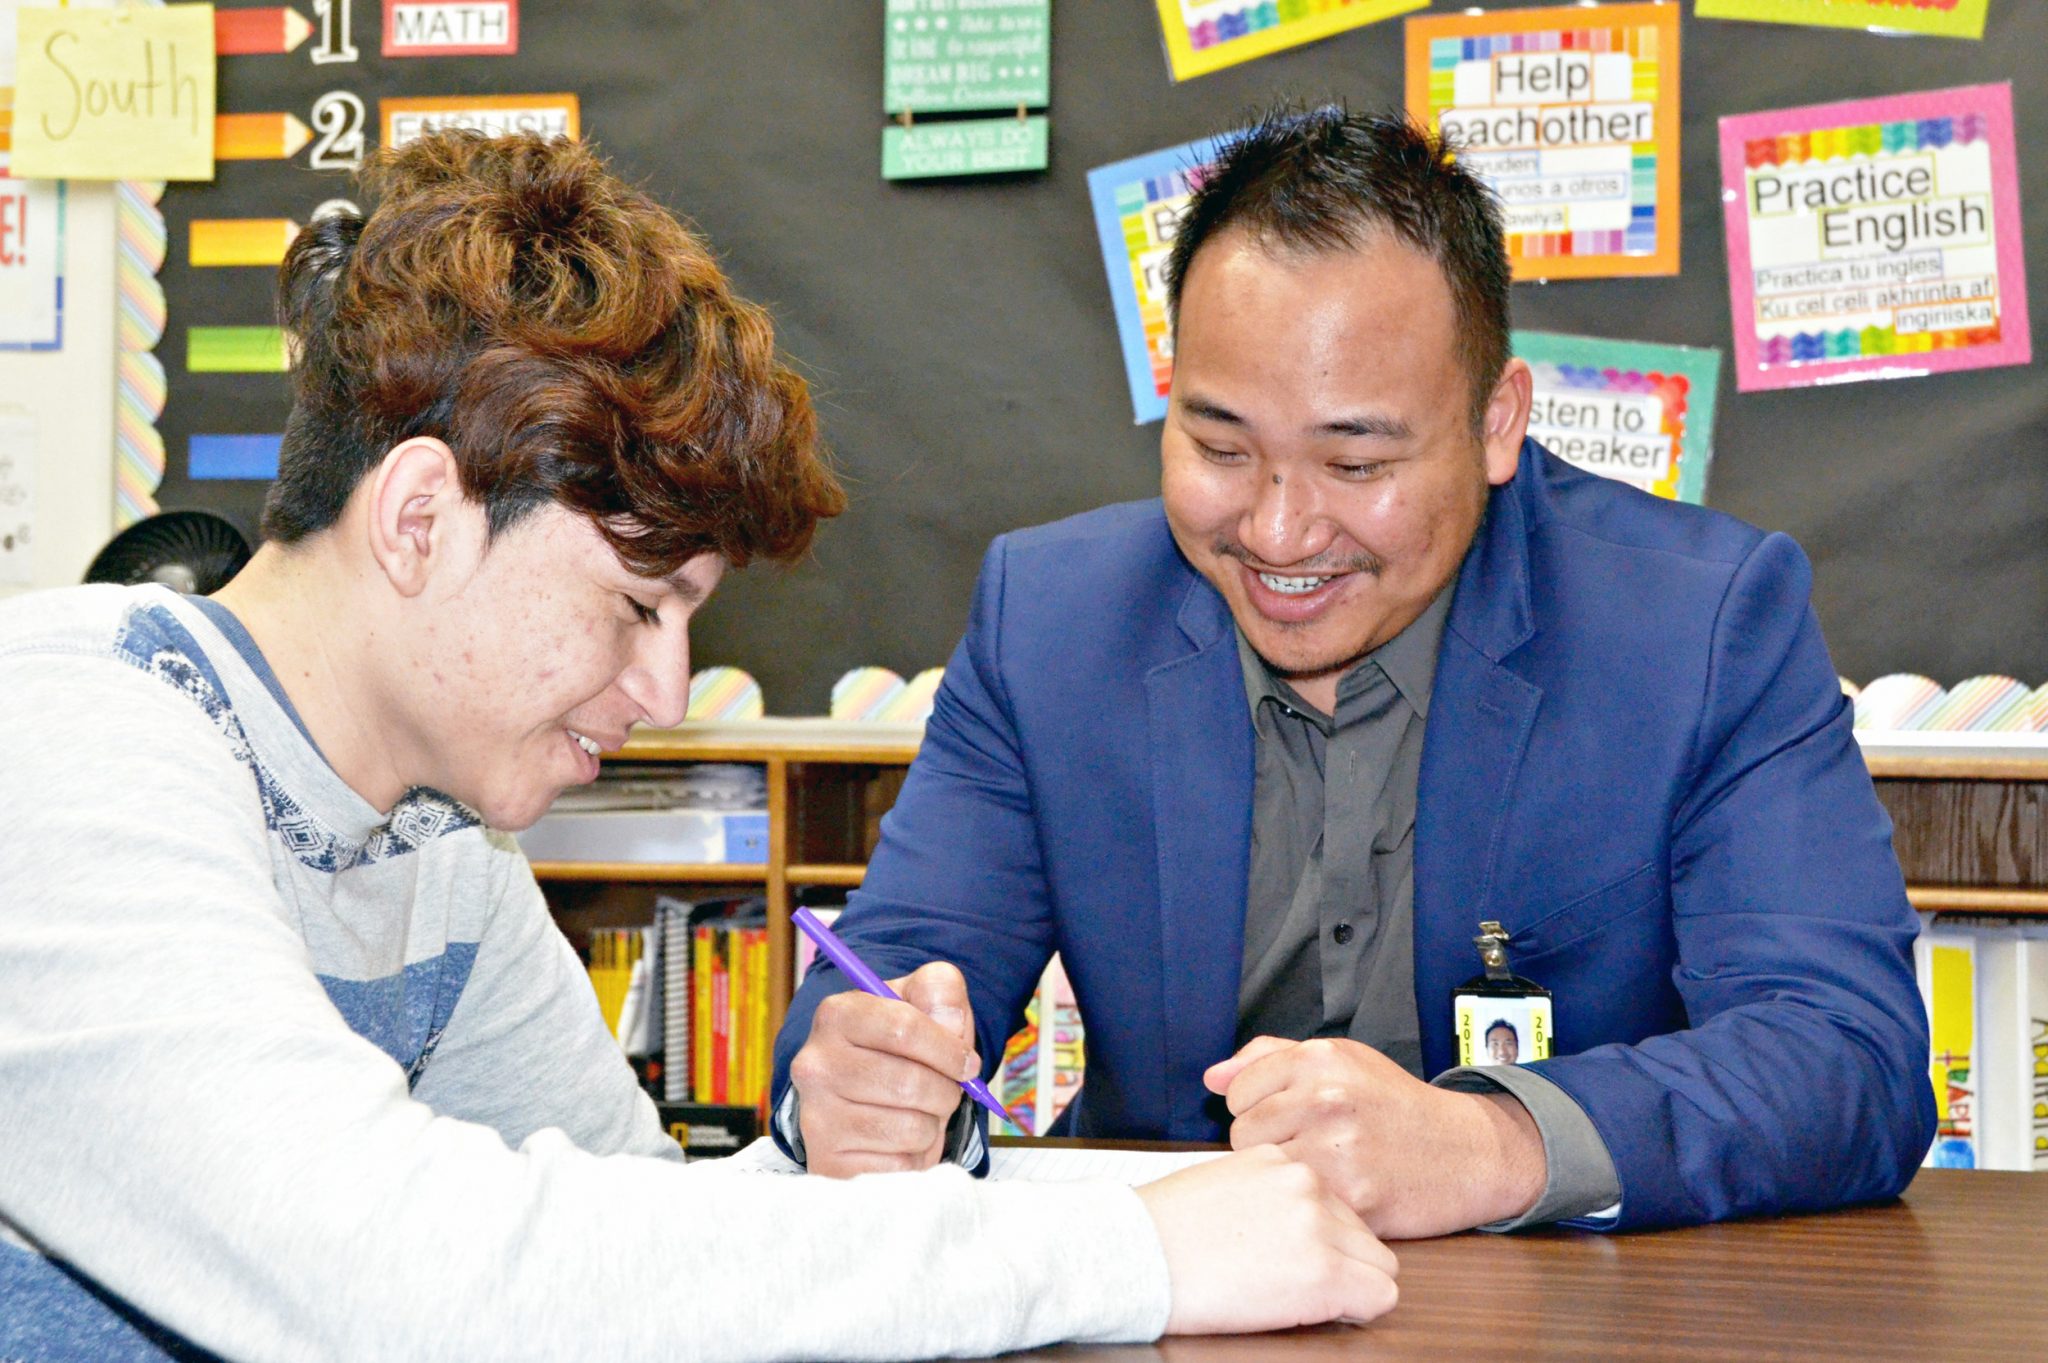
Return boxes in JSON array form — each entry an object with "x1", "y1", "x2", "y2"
[{"x1": 774, "y1": 442, "x2": 1933, "y2": 1226}]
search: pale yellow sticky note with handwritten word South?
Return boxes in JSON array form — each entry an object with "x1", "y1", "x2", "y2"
[{"x1": 12, "y1": 4, "x2": 213, "y2": 180}]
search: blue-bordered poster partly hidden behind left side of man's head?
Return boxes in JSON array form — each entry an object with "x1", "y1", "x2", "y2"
[{"x1": 1087, "y1": 137, "x2": 1223, "y2": 426}]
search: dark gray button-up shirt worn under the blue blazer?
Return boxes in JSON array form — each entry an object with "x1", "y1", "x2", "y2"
[{"x1": 1237, "y1": 587, "x2": 1620, "y2": 1230}]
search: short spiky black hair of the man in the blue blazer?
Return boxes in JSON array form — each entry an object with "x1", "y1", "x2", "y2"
[{"x1": 1165, "y1": 104, "x2": 1513, "y2": 430}]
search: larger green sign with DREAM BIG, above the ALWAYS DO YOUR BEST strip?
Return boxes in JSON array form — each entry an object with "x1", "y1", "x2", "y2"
[{"x1": 883, "y1": 0, "x2": 1053, "y2": 115}]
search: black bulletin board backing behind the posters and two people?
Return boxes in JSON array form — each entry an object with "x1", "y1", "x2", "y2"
[{"x1": 160, "y1": 0, "x2": 2048, "y2": 714}]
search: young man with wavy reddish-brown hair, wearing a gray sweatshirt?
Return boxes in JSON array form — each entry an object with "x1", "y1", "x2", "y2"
[{"x1": 0, "y1": 135, "x2": 1395, "y2": 1363}]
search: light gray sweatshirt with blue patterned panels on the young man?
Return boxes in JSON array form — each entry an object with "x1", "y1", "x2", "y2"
[{"x1": 0, "y1": 587, "x2": 1169, "y2": 1363}]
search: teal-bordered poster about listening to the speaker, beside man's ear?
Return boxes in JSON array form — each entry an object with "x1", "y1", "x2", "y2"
[{"x1": 1511, "y1": 332, "x2": 1720, "y2": 503}]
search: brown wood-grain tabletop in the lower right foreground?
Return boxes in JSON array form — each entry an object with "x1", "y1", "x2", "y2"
[{"x1": 1012, "y1": 1169, "x2": 2048, "y2": 1363}]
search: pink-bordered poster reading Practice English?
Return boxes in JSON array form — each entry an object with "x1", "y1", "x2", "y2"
[{"x1": 1720, "y1": 84, "x2": 2034, "y2": 391}]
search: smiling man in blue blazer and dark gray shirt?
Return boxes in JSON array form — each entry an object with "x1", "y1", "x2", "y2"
[{"x1": 774, "y1": 111, "x2": 1933, "y2": 1236}]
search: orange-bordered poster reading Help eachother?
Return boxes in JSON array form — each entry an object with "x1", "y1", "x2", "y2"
[{"x1": 1407, "y1": 4, "x2": 1679, "y2": 280}]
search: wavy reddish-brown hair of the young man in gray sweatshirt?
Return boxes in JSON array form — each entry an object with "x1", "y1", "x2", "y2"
[{"x1": 262, "y1": 131, "x2": 846, "y2": 577}]
